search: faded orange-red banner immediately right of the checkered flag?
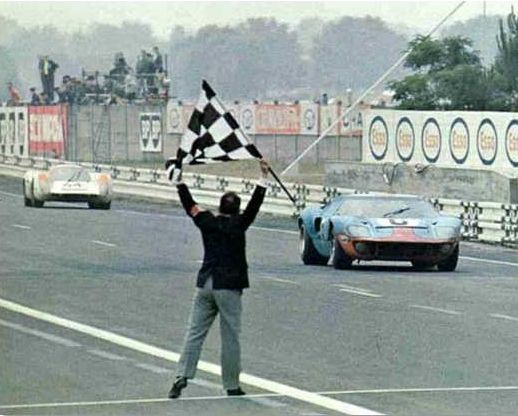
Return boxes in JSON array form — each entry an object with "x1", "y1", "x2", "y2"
[{"x1": 255, "y1": 104, "x2": 300, "y2": 134}]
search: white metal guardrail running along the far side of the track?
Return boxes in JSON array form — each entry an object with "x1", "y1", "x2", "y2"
[{"x1": 0, "y1": 155, "x2": 518, "y2": 245}]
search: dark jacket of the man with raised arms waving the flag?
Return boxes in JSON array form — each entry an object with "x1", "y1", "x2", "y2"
[{"x1": 177, "y1": 184, "x2": 266, "y2": 290}]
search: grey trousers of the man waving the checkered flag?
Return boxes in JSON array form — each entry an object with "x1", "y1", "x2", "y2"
[{"x1": 176, "y1": 288, "x2": 241, "y2": 390}]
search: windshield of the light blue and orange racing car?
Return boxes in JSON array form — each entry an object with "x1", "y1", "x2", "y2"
[{"x1": 338, "y1": 198, "x2": 438, "y2": 218}]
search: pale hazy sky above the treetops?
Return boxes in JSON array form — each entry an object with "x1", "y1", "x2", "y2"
[{"x1": 0, "y1": 0, "x2": 513, "y2": 37}]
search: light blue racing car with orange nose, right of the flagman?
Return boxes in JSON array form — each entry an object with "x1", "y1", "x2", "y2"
[{"x1": 298, "y1": 194, "x2": 461, "y2": 271}]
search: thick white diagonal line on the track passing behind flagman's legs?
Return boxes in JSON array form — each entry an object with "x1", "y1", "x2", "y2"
[{"x1": 0, "y1": 298, "x2": 381, "y2": 416}]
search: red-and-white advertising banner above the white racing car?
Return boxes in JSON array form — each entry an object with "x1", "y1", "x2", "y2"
[{"x1": 29, "y1": 105, "x2": 67, "y2": 158}]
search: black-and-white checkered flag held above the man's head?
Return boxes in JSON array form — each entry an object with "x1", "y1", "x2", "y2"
[{"x1": 165, "y1": 80, "x2": 262, "y2": 181}]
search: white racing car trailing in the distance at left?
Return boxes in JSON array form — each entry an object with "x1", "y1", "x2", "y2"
[{"x1": 23, "y1": 164, "x2": 112, "y2": 209}]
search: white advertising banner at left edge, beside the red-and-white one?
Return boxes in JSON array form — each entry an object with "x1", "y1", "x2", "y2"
[{"x1": 0, "y1": 107, "x2": 29, "y2": 156}]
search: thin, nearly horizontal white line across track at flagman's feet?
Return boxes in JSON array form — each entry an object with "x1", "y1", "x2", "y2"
[{"x1": 0, "y1": 386, "x2": 518, "y2": 410}]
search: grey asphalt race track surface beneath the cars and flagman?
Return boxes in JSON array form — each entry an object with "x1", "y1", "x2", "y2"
[{"x1": 0, "y1": 177, "x2": 518, "y2": 416}]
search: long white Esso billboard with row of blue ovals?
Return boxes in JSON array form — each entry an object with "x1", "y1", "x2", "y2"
[{"x1": 362, "y1": 110, "x2": 518, "y2": 170}]
